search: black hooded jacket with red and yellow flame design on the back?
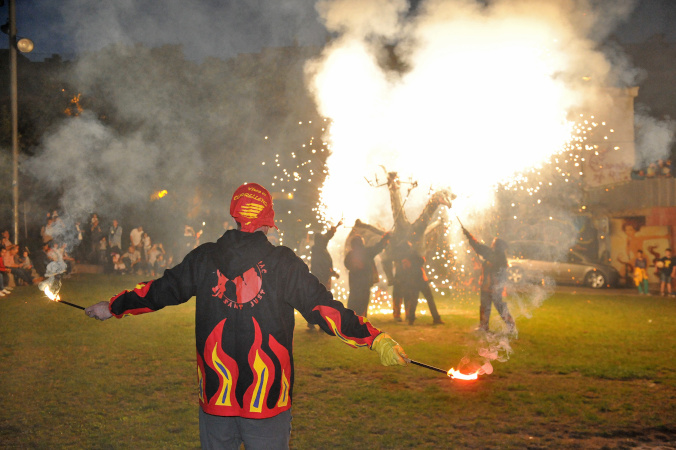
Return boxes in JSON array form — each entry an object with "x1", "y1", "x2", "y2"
[{"x1": 110, "y1": 230, "x2": 380, "y2": 419}]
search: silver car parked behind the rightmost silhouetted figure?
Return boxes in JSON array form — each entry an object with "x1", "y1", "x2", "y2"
[{"x1": 507, "y1": 241, "x2": 620, "y2": 289}]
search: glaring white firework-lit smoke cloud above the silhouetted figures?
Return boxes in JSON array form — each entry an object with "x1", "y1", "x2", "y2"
[{"x1": 307, "y1": 0, "x2": 652, "y2": 227}]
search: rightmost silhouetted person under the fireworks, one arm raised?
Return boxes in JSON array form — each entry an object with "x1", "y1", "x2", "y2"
[{"x1": 462, "y1": 227, "x2": 516, "y2": 334}]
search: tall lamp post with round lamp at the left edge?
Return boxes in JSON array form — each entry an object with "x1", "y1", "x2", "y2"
[{"x1": 2, "y1": 0, "x2": 33, "y2": 244}]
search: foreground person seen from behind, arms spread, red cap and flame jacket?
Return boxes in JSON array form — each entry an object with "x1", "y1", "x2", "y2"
[{"x1": 85, "y1": 183, "x2": 407, "y2": 449}]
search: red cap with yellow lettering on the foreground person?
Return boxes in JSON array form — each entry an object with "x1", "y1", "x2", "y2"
[{"x1": 230, "y1": 183, "x2": 277, "y2": 233}]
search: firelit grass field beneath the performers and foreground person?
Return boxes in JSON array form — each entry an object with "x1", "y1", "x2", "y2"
[{"x1": 0, "y1": 275, "x2": 676, "y2": 449}]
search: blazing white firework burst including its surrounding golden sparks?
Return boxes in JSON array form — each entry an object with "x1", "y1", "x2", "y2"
[{"x1": 254, "y1": 0, "x2": 633, "y2": 312}]
